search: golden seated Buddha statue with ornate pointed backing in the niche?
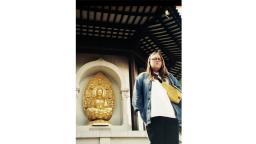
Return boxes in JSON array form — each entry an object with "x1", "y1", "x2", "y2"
[{"x1": 83, "y1": 73, "x2": 114, "y2": 125}]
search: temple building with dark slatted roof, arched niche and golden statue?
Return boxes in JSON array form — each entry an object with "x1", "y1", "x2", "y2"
[{"x1": 76, "y1": 1, "x2": 182, "y2": 144}]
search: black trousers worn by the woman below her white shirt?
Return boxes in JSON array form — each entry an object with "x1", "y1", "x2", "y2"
[{"x1": 146, "y1": 116, "x2": 179, "y2": 144}]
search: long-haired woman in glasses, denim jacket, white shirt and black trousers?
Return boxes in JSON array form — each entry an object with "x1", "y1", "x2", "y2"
[{"x1": 132, "y1": 51, "x2": 181, "y2": 144}]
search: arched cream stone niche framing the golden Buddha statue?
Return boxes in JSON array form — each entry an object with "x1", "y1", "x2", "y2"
[{"x1": 76, "y1": 58, "x2": 131, "y2": 130}]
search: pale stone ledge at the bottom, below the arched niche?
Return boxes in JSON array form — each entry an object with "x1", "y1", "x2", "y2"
[{"x1": 76, "y1": 126, "x2": 182, "y2": 144}]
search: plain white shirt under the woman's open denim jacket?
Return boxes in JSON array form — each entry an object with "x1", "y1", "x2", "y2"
[{"x1": 151, "y1": 80, "x2": 176, "y2": 118}]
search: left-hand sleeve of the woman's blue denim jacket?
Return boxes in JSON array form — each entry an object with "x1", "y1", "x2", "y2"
[{"x1": 132, "y1": 75, "x2": 143, "y2": 112}]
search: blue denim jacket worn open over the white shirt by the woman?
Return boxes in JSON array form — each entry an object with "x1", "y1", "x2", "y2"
[{"x1": 132, "y1": 72, "x2": 181, "y2": 125}]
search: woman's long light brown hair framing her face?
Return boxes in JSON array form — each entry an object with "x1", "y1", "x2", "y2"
[{"x1": 146, "y1": 50, "x2": 169, "y2": 80}]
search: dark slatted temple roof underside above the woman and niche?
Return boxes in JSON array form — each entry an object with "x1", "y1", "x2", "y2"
[{"x1": 76, "y1": 5, "x2": 181, "y2": 79}]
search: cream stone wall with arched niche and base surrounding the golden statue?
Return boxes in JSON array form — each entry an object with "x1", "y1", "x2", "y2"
[{"x1": 76, "y1": 54, "x2": 149, "y2": 144}]
